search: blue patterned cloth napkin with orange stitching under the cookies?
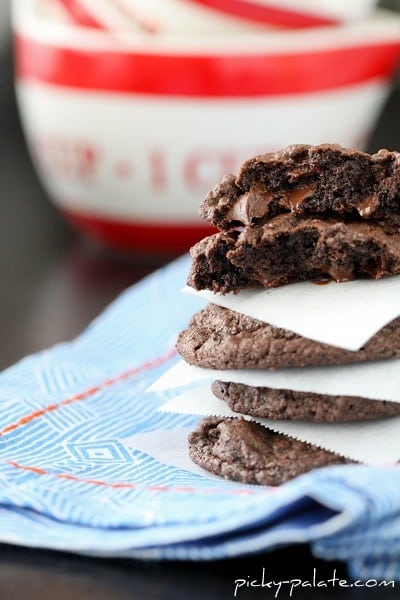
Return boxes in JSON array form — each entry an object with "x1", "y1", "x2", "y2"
[{"x1": 0, "y1": 257, "x2": 400, "y2": 579}]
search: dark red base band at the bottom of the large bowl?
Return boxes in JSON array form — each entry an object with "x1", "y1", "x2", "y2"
[{"x1": 61, "y1": 208, "x2": 216, "y2": 256}]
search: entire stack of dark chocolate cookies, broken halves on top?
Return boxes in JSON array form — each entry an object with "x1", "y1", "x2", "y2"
[{"x1": 177, "y1": 144, "x2": 400, "y2": 485}]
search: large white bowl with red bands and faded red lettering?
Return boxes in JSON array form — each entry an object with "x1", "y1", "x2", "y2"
[{"x1": 14, "y1": 0, "x2": 400, "y2": 253}]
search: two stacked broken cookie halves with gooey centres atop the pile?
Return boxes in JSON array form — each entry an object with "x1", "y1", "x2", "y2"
[{"x1": 188, "y1": 144, "x2": 400, "y2": 294}]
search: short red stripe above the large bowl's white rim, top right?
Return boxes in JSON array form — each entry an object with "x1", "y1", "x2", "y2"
[{"x1": 188, "y1": 0, "x2": 339, "y2": 29}]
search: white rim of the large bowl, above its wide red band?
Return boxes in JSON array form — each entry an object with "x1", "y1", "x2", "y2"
[{"x1": 12, "y1": 0, "x2": 400, "y2": 55}]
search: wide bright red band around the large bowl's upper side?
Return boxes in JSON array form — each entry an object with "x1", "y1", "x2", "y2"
[{"x1": 15, "y1": 36, "x2": 400, "y2": 98}]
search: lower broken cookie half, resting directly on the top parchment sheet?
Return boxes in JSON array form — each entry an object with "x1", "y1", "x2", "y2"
[{"x1": 188, "y1": 214, "x2": 400, "y2": 294}]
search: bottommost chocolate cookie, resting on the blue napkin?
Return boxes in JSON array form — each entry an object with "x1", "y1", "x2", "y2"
[{"x1": 189, "y1": 417, "x2": 352, "y2": 485}]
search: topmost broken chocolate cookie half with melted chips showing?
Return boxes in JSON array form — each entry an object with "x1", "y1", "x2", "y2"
[{"x1": 200, "y1": 144, "x2": 400, "y2": 229}]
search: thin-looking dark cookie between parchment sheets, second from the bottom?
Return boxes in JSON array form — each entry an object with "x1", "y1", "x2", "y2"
[{"x1": 211, "y1": 381, "x2": 400, "y2": 423}]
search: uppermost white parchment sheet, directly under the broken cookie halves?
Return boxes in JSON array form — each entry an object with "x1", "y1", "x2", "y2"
[{"x1": 184, "y1": 276, "x2": 400, "y2": 351}]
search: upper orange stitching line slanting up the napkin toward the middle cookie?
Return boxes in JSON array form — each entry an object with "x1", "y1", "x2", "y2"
[{"x1": 0, "y1": 348, "x2": 176, "y2": 436}]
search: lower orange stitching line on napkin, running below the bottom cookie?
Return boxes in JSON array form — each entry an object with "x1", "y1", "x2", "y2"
[{"x1": 1, "y1": 460, "x2": 279, "y2": 496}]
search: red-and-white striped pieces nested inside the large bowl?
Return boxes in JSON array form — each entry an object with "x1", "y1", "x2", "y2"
[{"x1": 46, "y1": 0, "x2": 376, "y2": 34}]
